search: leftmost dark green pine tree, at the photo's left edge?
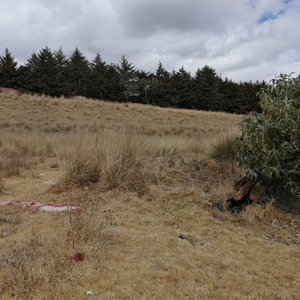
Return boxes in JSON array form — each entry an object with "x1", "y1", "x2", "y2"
[{"x1": 0, "y1": 48, "x2": 18, "y2": 88}]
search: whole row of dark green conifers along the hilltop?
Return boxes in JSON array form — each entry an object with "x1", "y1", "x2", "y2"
[{"x1": 0, "y1": 47, "x2": 267, "y2": 114}]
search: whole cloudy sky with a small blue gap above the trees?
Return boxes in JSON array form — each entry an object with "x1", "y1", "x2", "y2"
[{"x1": 0, "y1": 0, "x2": 300, "y2": 82}]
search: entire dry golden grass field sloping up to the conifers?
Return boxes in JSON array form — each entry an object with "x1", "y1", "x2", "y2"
[{"x1": 0, "y1": 94, "x2": 300, "y2": 300}]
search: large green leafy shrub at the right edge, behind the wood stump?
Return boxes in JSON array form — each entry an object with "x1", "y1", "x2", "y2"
[{"x1": 237, "y1": 74, "x2": 300, "y2": 197}]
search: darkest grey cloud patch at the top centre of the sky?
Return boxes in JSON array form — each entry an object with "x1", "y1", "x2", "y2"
[{"x1": 111, "y1": 0, "x2": 243, "y2": 36}]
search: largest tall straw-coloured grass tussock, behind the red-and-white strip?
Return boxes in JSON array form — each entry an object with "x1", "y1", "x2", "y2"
[{"x1": 58, "y1": 129, "x2": 148, "y2": 194}]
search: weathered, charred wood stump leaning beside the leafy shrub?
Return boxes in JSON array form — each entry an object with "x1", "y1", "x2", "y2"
[{"x1": 226, "y1": 169, "x2": 261, "y2": 212}]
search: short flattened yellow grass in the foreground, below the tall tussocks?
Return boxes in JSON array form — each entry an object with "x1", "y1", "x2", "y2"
[{"x1": 0, "y1": 159, "x2": 300, "y2": 299}]
